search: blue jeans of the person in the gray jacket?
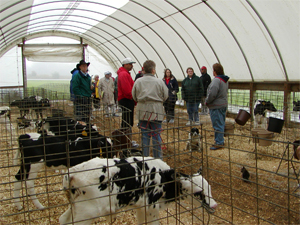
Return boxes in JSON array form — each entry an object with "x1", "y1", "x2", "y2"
[{"x1": 209, "y1": 107, "x2": 227, "y2": 145}]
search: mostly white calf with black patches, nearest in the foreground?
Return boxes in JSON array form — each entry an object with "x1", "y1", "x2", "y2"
[{"x1": 59, "y1": 157, "x2": 217, "y2": 224}]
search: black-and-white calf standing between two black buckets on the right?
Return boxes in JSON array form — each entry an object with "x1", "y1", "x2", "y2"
[{"x1": 254, "y1": 99, "x2": 277, "y2": 129}]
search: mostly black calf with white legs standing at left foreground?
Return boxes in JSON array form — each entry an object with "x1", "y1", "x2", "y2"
[{"x1": 14, "y1": 125, "x2": 112, "y2": 210}]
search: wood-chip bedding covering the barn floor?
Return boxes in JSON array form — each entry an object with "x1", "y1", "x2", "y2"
[{"x1": 0, "y1": 96, "x2": 300, "y2": 224}]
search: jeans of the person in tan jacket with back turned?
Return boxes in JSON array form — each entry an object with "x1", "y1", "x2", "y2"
[{"x1": 140, "y1": 120, "x2": 163, "y2": 158}]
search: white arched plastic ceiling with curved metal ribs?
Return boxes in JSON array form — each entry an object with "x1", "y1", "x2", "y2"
[{"x1": 0, "y1": 0, "x2": 300, "y2": 82}]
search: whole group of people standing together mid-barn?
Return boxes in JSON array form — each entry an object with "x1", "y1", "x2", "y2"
[{"x1": 71, "y1": 58, "x2": 229, "y2": 158}]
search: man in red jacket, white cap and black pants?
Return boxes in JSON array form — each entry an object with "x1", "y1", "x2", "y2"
[{"x1": 117, "y1": 58, "x2": 135, "y2": 128}]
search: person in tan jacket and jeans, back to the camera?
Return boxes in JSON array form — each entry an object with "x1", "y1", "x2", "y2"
[{"x1": 132, "y1": 60, "x2": 169, "y2": 158}]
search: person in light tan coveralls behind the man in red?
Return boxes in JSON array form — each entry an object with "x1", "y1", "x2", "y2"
[{"x1": 98, "y1": 71, "x2": 117, "y2": 117}]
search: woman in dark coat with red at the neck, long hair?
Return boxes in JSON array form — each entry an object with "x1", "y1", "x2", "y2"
[{"x1": 163, "y1": 69, "x2": 179, "y2": 123}]
